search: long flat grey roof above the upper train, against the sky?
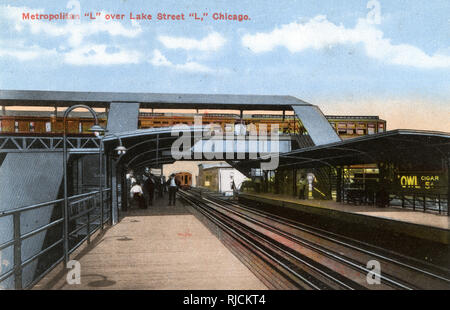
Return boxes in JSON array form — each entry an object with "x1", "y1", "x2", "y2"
[{"x1": 0, "y1": 90, "x2": 312, "y2": 111}]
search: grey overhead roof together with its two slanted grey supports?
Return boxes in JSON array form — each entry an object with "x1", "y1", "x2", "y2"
[{"x1": 0, "y1": 90, "x2": 340, "y2": 145}]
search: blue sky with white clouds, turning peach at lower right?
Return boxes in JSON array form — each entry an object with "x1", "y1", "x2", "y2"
[{"x1": 0, "y1": 0, "x2": 450, "y2": 132}]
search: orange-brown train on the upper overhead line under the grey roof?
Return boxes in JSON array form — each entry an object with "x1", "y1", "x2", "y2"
[{"x1": 0, "y1": 111, "x2": 386, "y2": 139}]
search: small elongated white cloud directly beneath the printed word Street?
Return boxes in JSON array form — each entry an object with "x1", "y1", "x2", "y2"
[{"x1": 158, "y1": 32, "x2": 226, "y2": 52}]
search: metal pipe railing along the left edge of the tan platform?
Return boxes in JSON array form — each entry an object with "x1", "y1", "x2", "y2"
[{"x1": 0, "y1": 188, "x2": 111, "y2": 289}]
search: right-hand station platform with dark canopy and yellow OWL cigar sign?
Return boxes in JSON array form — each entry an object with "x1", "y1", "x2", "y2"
[{"x1": 237, "y1": 130, "x2": 450, "y2": 245}]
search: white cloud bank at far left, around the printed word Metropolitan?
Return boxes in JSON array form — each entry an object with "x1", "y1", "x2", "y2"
[{"x1": 0, "y1": 5, "x2": 143, "y2": 66}]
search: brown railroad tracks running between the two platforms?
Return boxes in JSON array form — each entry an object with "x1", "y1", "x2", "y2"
[{"x1": 179, "y1": 190, "x2": 450, "y2": 290}]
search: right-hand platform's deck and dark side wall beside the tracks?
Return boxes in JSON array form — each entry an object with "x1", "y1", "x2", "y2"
[{"x1": 238, "y1": 193, "x2": 450, "y2": 256}]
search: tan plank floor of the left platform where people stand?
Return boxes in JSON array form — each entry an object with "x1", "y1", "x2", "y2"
[{"x1": 33, "y1": 197, "x2": 266, "y2": 290}]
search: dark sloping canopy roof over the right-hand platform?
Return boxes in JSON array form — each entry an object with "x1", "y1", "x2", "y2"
[{"x1": 235, "y1": 129, "x2": 450, "y2": 170}]
